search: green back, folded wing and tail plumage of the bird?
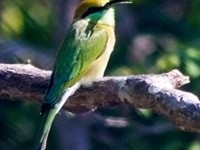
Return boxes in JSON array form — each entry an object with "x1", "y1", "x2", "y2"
[{"x1": 37, "y1": 20, "x2": 108, "y2": 150}]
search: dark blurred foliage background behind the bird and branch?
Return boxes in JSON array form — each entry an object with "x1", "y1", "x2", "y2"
[{"x1": 0, "y1": 0, "x2": 200, "y2": 150}]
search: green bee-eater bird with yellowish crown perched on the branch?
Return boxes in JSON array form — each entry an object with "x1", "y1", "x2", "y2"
[{"x1": 36, "y1": 0, "x2": 130, "y2": 150}]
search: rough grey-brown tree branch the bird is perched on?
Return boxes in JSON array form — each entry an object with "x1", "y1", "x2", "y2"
[{"x1": 0, "y1": 64, "x2": 200, "y2": 133}]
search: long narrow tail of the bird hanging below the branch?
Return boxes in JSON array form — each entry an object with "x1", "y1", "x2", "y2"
[{"x1": 36, "y1": 83, "x2": 80, "y2": 150}]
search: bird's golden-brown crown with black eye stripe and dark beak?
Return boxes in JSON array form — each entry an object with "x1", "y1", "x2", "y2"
[{"x1": 74, "y1": 0, "x2": 131, "y2": 19}]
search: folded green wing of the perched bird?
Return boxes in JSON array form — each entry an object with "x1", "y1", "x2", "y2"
[{"x1": 43, "y1": 22, "x2": 108, "y2": 110}]
